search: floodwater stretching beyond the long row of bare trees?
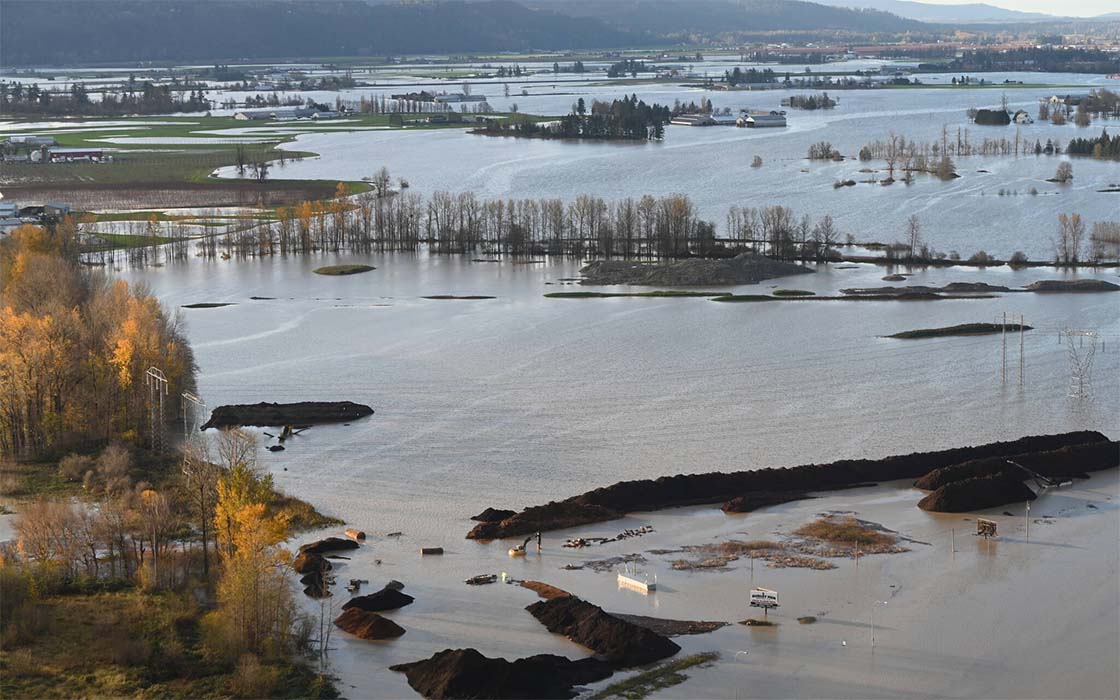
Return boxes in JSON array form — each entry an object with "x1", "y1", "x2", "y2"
[{"x1": 223, "y1": 74, "x2": 1120, "y2": 260}]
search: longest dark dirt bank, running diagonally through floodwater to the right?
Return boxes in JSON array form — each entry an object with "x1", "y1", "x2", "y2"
[{"x1": 467, "y1": 430, "x2": 1108, "y2": 540}]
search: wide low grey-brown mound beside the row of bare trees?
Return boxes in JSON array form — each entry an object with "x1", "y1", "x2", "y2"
[{"x1": 580, "y1": 253, "x2": 813, "y2": 287}]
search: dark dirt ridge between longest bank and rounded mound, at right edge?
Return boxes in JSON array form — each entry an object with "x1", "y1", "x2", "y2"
[{"x1": 914, "y1": 441, "x2": 1120, "y2": 491}]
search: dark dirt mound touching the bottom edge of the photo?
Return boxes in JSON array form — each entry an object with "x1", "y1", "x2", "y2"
[{"x1": 390, "y1": 648, "x2": 614, "y2": 700}]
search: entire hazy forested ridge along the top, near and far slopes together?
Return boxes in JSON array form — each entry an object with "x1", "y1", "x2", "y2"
[{"x1": 0, "y1": 0, "x2": 936, "y2": 66}]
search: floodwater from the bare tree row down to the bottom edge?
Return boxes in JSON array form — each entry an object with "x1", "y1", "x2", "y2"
[{"x1": 123, "y1": 254, "x2": 1120, "y2": 698}]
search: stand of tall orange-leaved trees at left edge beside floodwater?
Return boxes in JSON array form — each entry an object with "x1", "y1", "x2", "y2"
[{"x1": 0, "y1": 218, "x2": 195, "y2": 458}]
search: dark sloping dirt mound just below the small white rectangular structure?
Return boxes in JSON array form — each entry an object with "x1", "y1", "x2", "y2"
[{"x1": 525, "y1": 596, "x2": 681, "y2": 668}]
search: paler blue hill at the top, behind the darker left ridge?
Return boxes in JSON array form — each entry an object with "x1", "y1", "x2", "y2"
[{"x1": 524, "y1": 0, "x2": 931, "y2": 37}]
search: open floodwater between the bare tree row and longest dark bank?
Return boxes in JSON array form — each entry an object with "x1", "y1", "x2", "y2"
[{"x1": 129, "y1": 255, "x2": 1120, "y2": 540}]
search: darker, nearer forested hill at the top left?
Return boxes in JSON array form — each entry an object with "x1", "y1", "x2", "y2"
[{"x1": 0, "y1": 0, "x2": 654, "y2": 66}]
